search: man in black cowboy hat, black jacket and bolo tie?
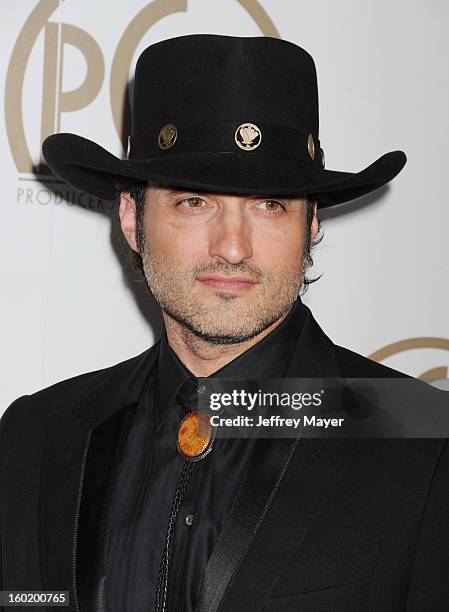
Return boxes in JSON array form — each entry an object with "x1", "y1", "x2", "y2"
[{"x1": 1, "y1": 35, "x2": 449, "y2": 612}]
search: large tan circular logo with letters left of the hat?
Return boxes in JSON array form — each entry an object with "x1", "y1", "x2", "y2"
[{"x1": 5, "y1": 0, "x2": 279, "y2": 208}]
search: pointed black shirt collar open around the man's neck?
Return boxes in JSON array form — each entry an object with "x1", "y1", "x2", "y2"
[{"x1": 157, "y1": 296, "x2": 304, "y2": 415}]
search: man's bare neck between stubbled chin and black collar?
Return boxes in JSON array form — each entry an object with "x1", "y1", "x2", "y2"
[{"x1": 163, "y1": 312, "x2": 288, "y2": 378}]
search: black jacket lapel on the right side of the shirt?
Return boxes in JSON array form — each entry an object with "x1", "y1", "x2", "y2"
[{"x1": 195, "y1": 304, "x2": 358, "y2": 612}]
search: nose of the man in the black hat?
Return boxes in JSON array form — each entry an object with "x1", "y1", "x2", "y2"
[{"x1": 209, "y1": 199, "x2": 253, "y2": 264}]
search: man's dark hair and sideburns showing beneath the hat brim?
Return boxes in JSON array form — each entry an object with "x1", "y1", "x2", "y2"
[{"x1": 114, "y1": 181, "x2": 325, "y2": 294}]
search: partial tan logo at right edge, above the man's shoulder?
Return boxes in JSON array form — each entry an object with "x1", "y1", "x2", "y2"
[{"x1": 369, "y1": 336, "x2": 449, "y2": 388}]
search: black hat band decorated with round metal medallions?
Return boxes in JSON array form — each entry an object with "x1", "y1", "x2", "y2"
[{"x1": 128, "y1": 121, "x2": 323, "y2": 167}]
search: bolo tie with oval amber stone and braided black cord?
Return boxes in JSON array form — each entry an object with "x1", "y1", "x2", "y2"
[{"x1": 154, "y1": 382, "x2": 215, "y2": 612}]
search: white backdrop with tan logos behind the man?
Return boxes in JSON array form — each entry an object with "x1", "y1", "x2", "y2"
[{"x1": 0, "y1": 0, "x2": 449, "y2": 414}]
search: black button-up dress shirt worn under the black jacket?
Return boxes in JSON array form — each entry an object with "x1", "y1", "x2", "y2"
[{"x1": 106, "y1": 297, "x2": 303, "y2": 612}]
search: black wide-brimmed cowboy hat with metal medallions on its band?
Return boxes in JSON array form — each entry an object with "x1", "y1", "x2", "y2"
[{"x1": 43, "y1": 34, "x2": 406, "y2": 207}]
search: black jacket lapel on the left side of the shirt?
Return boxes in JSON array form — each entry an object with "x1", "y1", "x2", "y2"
[{"x1": 40, "y1": 343, "x2": 159, "y2": 610}]
